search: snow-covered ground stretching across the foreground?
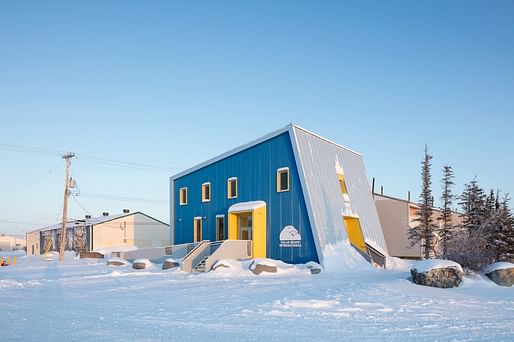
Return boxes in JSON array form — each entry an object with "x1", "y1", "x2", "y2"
[{"x1": 0, "y1": 252, "x2": 514, "y2": 341}]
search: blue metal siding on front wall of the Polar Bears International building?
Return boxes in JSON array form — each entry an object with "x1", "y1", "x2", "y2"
[{"x1": 171, "y1": 132, "x2": 318, "y2": 263}]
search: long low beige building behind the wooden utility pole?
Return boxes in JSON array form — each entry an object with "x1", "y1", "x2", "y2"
[{"x1": 27, "y1": 210, "x2": 170, "y2": 255}]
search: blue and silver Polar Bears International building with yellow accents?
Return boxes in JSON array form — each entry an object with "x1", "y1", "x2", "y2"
[{"x1": 170, "y1": 125, "x2": 387, "y2": 263}]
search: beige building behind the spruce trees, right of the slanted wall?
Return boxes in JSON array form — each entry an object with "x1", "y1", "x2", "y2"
[{"x1": 374, "y1": 194, "x2": 462, "y2": 259}]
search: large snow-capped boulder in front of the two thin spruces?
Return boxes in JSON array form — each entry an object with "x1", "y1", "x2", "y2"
[{"x1": 410, "y1": 259, "x2": 464, "y2": 288}]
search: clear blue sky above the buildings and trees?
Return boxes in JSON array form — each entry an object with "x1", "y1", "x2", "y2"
[{"x1": 0, "y1": 1, "x2": 514, "y2": 232}]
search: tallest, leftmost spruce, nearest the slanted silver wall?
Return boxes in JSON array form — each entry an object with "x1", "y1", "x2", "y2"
[{"x1": 407, "y1": 145, "x2": 437, "y2": 259}]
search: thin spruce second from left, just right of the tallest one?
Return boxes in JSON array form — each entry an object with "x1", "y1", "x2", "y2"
[{"x1": 438, "y1": 165, "x2": 454, "y2": 259}]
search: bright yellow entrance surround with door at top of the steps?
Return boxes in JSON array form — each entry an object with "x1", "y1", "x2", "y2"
[{"x1": 228, "y1": 206, "x2": 266, "y2": 258}]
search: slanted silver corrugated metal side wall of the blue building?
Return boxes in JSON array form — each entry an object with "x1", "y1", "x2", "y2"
[{"x1": 293, "y1": 126, "x2": 387, "y2": 260}]
